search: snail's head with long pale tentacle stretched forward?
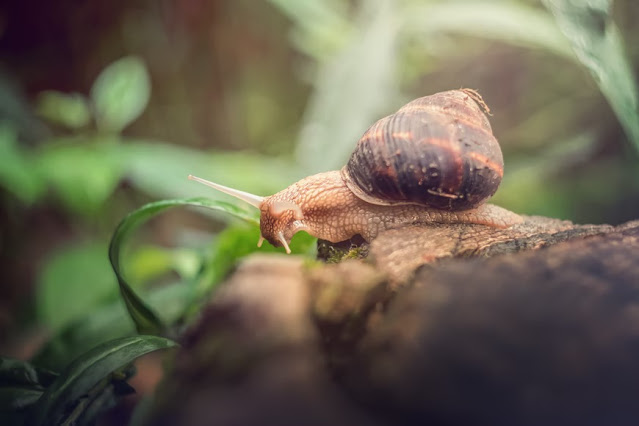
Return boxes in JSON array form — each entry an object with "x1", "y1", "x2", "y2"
[{"x1": 189, "y1": 175, "x2": 305, "y2": 253}]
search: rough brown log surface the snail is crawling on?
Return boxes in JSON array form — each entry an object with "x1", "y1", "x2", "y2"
[{"x1": 150, "y1": 217, "x2": 639, "y2": 425}]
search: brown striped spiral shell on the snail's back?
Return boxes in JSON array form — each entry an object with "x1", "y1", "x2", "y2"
[{"x1": 341, "y1": 89, "x2": 504, "y2": 210}]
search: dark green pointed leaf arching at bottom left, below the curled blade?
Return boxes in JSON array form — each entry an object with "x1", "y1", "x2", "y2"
[{"x1": 34, "y1": 336, "x2": 176, "y2": 425}]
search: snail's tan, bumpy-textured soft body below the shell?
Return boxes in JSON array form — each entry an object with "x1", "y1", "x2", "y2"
[{"x1": 260, "y1": 171, "x2": 522, "y2": 247}]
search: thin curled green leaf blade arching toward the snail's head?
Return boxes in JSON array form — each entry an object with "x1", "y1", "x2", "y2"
[{"x1": 109, "y1": 198, "x2": 259, "y2": 334}]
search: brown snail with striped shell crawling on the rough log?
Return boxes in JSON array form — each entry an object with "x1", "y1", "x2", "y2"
[{"x1": 189, "y1": 89, "x2": 522, "y2": 253}]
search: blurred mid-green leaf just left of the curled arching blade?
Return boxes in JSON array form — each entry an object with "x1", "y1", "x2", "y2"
[{"x1": 36, "y1": 242, "x2": 117, "y2": 333}]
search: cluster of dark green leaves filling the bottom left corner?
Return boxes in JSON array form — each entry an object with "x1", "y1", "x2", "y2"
[{"x1": 0, "y1": 336, "x2": 175, "y2": 425}]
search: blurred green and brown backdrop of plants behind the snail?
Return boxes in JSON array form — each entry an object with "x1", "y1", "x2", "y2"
[{"x1": 0, "y1": 0, "x2": 639, "y2": 418}]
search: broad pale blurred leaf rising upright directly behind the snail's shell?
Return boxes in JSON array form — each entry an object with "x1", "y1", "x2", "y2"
[{"x1": 296, "y1": 0, "x2": 399, "y2": 172}]
